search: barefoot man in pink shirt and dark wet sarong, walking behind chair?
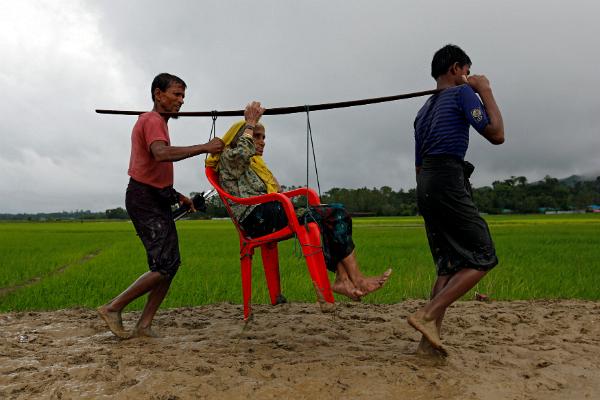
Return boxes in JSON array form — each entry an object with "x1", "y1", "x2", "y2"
[{"x1": 98, "y1": 73, "x2": 236, "y2": 338}]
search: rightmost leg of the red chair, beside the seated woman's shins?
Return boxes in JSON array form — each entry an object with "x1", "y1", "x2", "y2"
[{"x1": 298, "y1": 222, "x2": 334, "y2": 303}]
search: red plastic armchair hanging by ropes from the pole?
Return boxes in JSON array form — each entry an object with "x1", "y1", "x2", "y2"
[{"x1": 206, "y1": 167, "x2": 334, "y2": 320}]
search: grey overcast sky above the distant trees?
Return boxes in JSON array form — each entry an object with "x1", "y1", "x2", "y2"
[{"x1": 0, "y1": 0, "x2": 600, "y2": 213}]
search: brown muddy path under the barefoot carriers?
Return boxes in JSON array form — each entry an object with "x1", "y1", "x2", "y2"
[{"x1": 0, "y1": 301, "x2": 600, "y2": 400}]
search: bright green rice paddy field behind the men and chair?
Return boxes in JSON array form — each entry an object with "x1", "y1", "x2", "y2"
[{"x1": 0, "y1": 214, "x2": 600, "y2": 312}]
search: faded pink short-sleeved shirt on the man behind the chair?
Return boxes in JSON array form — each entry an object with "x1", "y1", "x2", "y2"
[{"x1": 127, "y1": 111, "x2": 173, "y2": 189}]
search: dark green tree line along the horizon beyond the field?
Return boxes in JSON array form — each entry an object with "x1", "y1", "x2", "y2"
[{"x1": 0, "y1": 176, "x2": 600, "y2": 221}]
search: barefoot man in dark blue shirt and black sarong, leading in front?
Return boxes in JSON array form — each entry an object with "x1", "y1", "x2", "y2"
[{"x1": 408, "y1": 44, "x2": 504, "y2": 354}]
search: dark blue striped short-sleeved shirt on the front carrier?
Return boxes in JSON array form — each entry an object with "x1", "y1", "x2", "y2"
[{"x1": 414, "y1": 84, "x2": 490, "y2": 167}]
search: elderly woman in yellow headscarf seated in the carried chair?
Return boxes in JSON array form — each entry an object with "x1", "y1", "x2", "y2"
[{"x1": 206, "y1": 104, "x2": 392, "y2": 300}]
